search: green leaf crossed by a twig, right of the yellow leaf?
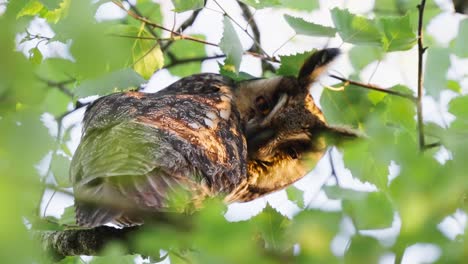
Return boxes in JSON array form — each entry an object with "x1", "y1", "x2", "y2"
[{"x1": 166, "y1": 35, "x2": 206, "y2": 76}]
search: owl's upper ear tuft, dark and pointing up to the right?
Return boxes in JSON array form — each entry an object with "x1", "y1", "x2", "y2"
[{"x1": 297, "y1": 48, "x2": 341, "y2": 86}]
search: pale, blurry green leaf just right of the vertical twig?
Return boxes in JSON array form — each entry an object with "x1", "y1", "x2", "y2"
[{"x1": 424, "y1": 47, "x2": 450, "y2": 100}]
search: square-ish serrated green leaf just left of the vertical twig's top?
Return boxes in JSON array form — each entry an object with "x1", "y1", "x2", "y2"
[{"x1": 377, "y1": 15, "x2": 416, "y2": 52}]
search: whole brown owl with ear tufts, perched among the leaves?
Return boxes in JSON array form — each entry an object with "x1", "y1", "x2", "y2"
[{"x1": 70, "y1": 49, "x2": 355, "y2": 227}]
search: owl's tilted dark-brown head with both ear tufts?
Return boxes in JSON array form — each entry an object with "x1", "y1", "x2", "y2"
[{"x1": 235, "y1": 49, "x2": 351, "y2": 162}]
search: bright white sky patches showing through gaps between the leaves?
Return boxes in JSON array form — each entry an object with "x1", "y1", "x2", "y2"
[{"x1": 14, "y1": 0, "x2": 468, "y2": 264}]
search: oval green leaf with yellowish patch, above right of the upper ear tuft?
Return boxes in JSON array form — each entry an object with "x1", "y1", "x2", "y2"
[{"x1": 331, "y1": 8, "x2": 382, "y2": 46}]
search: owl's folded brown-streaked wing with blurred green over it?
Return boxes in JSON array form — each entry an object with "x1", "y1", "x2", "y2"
[{"x1": 70, "y1": 74, "x2": 247, "y2": 226}]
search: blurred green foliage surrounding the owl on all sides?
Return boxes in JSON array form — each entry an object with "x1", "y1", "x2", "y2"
[{"x1": 0, "y1": 0, "x2": 468, "y2": 263}]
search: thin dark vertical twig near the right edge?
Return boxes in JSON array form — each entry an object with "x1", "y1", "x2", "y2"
[{"x1": 417, "y1": 0, "x2": 427, "y2": 151}]
